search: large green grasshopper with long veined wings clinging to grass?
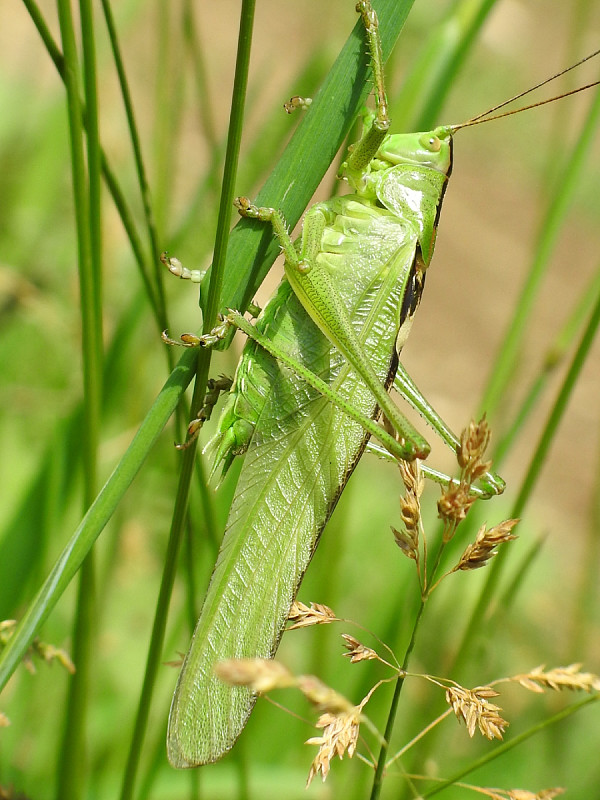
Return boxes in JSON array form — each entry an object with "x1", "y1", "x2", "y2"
[{"x1": 164, "y1": 0, "x2": 600, "y2": 768}]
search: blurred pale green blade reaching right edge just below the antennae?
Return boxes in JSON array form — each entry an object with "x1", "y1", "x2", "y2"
[{"x1": 480, "y1": 81, "x2": 600, "y2": 416}]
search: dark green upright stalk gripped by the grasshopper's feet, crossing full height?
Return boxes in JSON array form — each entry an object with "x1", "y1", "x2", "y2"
[{"x1": 120, "y1": 0, "x2": 255, "y2": 800}]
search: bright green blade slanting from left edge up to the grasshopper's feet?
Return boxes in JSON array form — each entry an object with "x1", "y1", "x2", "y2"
[{"x1": 0, "y1": 351, "x2": 196, "y2": 691}]
